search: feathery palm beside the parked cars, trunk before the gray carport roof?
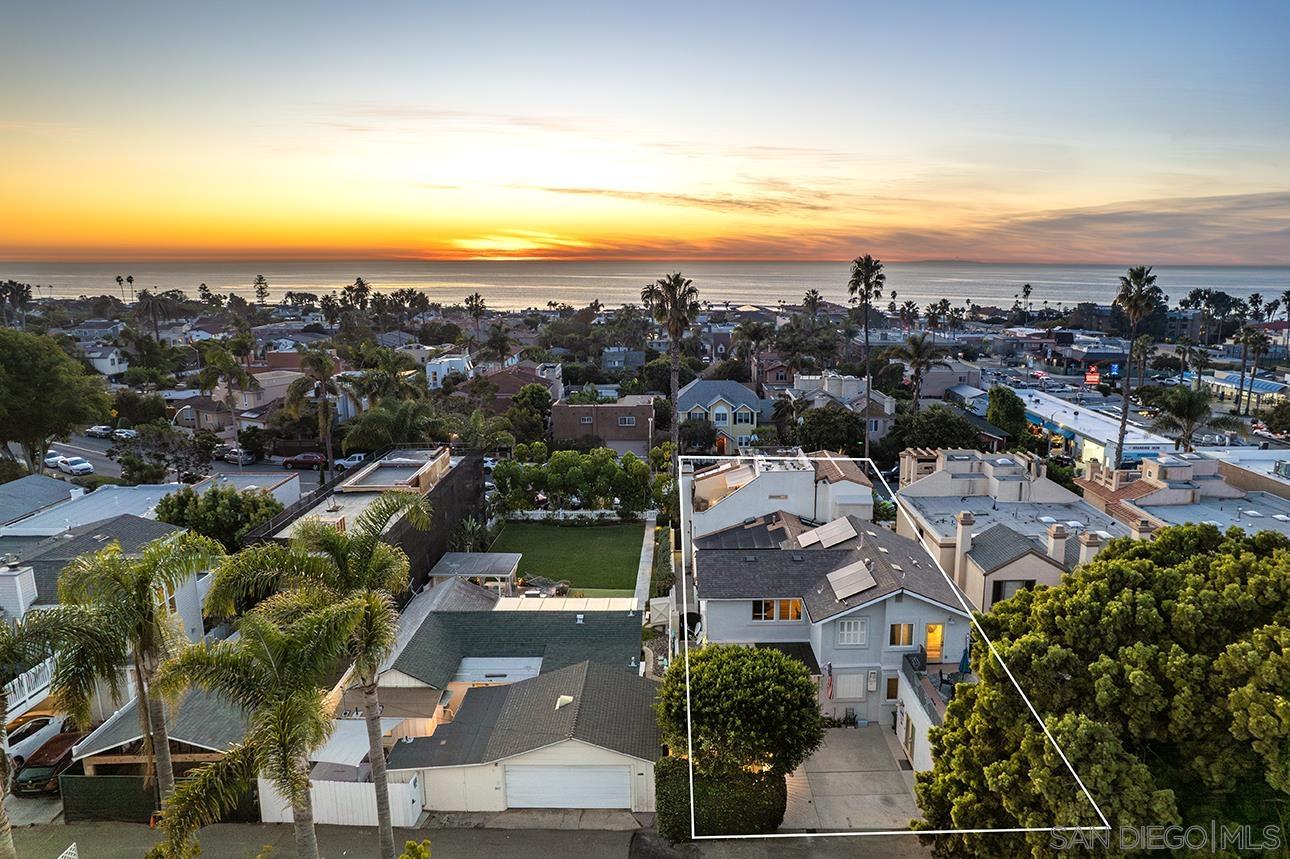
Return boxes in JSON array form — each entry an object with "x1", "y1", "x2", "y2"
[{"x1": 57, "y1": 531, "x2": 224, "y2": 801}]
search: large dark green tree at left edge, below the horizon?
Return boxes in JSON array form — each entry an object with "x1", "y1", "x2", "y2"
[{"x1": 0, "y1": 329, "x2": 108, "y2": 473}]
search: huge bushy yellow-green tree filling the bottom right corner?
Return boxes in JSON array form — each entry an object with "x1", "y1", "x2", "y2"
[{"x1": 915, "y1": 525, "x2": 1290, "y2": 856}]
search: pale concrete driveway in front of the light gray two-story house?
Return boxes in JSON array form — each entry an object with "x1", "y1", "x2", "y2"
[{"x1": 780, "y1": 725, "x2": 922, "y2": 832}]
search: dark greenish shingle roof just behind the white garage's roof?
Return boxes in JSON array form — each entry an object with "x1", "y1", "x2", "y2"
[{"x1": 392, "y1": 611, "x2": 641, "y2": 689}]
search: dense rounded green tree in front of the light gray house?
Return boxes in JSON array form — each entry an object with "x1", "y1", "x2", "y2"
[{"x1": 655, "y1": 645, "x2": 824, "y2": 775}]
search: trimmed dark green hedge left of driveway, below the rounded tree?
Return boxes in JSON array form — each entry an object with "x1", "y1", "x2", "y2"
[{"x1": 654, "y1": 757, "x2": 788, "y2": 841}]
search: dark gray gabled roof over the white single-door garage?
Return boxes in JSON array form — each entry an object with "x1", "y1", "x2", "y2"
[{"x1": 388, "y1": 662, "x2": 660, "y2": 770}]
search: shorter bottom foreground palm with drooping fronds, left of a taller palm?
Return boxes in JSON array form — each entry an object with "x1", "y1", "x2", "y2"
[{"x1": 156, "y1": 600, "x2": 361, "y2": 859}]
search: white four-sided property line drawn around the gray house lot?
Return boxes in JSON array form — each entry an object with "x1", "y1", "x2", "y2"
[{"x1": 676, "y1": 454, "x2": 1111, "y2": 841}]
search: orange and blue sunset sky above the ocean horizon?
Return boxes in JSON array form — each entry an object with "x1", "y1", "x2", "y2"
[{"x1": 0, "y1": 3, "x2": 1290, "y2": 264}]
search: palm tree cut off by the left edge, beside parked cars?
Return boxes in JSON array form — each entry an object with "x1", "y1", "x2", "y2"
[{"x1": 0, "y1": 606, "x2": 114, "y2": 858}]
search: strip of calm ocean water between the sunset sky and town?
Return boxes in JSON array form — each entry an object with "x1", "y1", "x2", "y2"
[{"x1": 0, "y1": 261, "x2": 1290, "y2": 310}]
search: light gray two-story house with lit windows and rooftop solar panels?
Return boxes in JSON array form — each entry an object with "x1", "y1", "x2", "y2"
[{"x1": 694, "y1": 513, "x2": 970, "y2": 726}]
